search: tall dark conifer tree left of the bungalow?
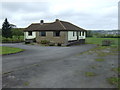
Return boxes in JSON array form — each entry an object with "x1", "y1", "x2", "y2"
[{"x1": 2, "y1": 18, "x2": 12, "y2": 38}]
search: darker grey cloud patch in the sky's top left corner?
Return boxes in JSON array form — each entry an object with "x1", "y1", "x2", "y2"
[{"x1": 2, "y1": 2, "x2": 49, "y2": 13}]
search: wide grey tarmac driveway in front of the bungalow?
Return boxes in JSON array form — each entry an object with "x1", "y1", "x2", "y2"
[{"x1": 2, "y1": 44, "x2": 115, "y2": 88}]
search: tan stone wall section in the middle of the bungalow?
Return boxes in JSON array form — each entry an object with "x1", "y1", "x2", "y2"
[{"x1": 36, "y1": 31, "x2": 68, "y2": 43}]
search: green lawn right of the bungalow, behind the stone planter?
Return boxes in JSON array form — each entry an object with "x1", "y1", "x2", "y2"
[{"x1": 86, "y1": 37, "x2": 119, "y2": 46}]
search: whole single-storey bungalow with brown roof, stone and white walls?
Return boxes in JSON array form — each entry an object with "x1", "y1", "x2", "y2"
[{"x1": 24, "y1": 19, "x2": 86, "y2": 44}]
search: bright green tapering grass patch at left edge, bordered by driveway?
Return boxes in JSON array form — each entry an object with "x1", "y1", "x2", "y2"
[{"x1": 0, "y1": 46, "x2": 24, "y2": 55}]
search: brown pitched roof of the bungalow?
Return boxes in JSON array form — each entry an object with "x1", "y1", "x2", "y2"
[{"x1": 24, "y1": 19, "x2": 86, "y2": 31}]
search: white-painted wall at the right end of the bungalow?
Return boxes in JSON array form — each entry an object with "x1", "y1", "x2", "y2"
[{"x1": 68, "y1": 31, "x2": 86, "y2": 41}]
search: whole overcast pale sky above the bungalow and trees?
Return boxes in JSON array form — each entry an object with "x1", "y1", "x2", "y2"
[{"x1": 0, "y1": 0, "x2": 119, "y2": 30}]
